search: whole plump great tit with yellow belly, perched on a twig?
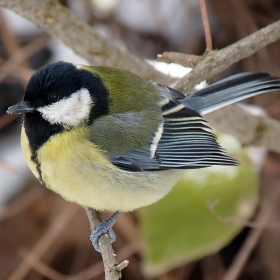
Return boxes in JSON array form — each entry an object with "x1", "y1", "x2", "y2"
[{"x1": 7, "y1": 61, "x2": 280, "y2": 250}]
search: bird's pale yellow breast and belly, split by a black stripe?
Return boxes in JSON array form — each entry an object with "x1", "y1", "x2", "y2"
[{"x1": 21, "y1": 123, "x2": 180, "y2": 211}]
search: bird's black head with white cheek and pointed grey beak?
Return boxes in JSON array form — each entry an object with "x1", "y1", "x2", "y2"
[{"x1": 7, "y1": 62, "x2": 108, "y2": 129}]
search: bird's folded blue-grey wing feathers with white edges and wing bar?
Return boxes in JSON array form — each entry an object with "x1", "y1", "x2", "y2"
[{"x1": 110, "y1": 83, "x2": 238, "y2": 172}]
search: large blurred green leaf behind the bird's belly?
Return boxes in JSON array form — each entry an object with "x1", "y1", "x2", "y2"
[{"x1": 140, "y1": 135, "x2": 258, "y2": 276}]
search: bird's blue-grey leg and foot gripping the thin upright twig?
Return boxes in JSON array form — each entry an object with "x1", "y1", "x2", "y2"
[{"x1": 90, "y1": 212, "x2": 121, "y2": 252}]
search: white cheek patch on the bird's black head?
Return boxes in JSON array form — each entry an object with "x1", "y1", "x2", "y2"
[{"x1": 37, "y1": 88, "x2": 93, "y2": 128}]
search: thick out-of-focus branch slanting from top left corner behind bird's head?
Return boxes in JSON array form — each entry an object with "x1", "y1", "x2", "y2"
[{"x1": 0, "y1": 0, "x2": 172, "y2": 84}]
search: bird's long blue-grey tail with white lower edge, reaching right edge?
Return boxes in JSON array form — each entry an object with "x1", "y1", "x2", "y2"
[{"x1": 181, "y1": 72, "x2": 280, "y2": 115}]
